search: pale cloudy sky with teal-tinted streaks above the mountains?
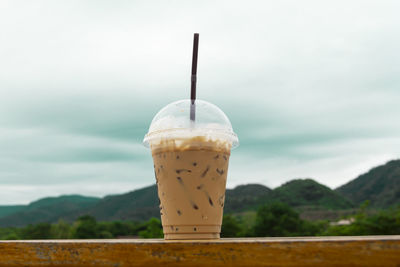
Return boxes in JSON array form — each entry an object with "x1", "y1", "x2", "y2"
[{"x1": 0, "y1": 0, "x2": 400, "y2": 205}]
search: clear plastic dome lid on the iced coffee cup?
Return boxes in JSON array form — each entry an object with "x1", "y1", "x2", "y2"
[{"x1": 143, "y1": 99, "x2": 239, "y2": 149}]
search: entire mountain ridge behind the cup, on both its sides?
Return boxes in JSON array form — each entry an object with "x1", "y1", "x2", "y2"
[{"x1": 0, "y1": 160, "x2": 400, "y2": 226}]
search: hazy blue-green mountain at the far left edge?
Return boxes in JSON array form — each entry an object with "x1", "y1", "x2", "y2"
[{"x1": 0, "y1": 195, "x2": 100, "y2": 226}]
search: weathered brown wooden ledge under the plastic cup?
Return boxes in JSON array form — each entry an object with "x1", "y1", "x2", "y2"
[{"x1": 0, "y1": 236, "x2": 400, "y2": 267}]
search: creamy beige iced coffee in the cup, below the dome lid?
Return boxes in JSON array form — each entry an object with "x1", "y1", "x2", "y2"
[{"x1": 151, "y1": 137, "x2": 230, "y2": 239}]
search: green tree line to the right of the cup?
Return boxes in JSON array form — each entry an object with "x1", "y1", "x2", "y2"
[{"x1": 221, "y1": 201, "x2": 400, "y2": 237}]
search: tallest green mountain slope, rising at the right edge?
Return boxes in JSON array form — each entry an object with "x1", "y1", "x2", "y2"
[{"x1": 335, "y1": 160, "x2": 400, "y2": 208}]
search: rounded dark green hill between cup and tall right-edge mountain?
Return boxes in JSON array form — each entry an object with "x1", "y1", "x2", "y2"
[{"x1": 269, "y1": 179, "x2": 353, "y2": 210}]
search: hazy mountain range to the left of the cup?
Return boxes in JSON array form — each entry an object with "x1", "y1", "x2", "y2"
[{"x1": 0, "y1": 185, "x2": 160, "y2": 227}]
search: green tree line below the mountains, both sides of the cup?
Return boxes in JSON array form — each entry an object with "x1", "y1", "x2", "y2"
[{"x1": 0, "y1": 202, "x2": 400, "y2": 240}]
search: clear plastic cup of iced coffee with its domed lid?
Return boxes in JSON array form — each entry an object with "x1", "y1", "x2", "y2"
[{"x1": 143, "y1": 100, "x2": 239, "y2": 239}]
